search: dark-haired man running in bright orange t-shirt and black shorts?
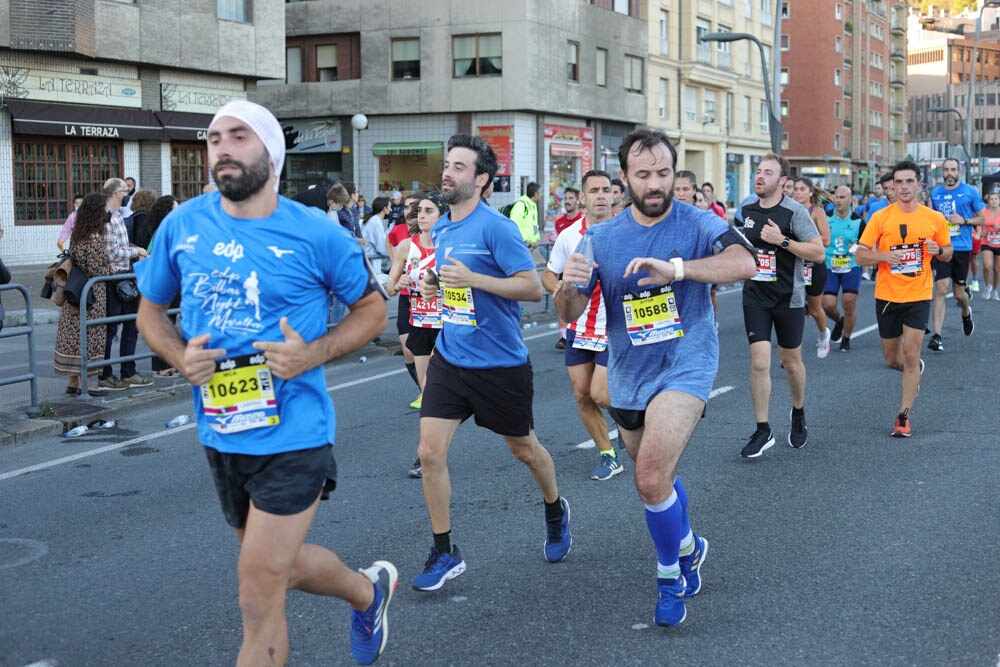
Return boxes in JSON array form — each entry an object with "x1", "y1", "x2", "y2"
[{"x1": 855, "y1": 160, "x2": 954, "y2": 438}]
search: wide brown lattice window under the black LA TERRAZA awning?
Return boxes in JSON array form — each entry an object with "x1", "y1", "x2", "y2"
[{"x1": 14, "y1": 136, "x2": 122, "y2": 224}]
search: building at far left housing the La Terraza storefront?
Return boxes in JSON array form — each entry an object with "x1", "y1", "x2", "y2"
[{"x1": 0, "y1": 0, "x2": 284, "y2": 264}]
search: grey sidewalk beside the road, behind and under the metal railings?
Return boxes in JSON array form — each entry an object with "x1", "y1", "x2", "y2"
[{"x1": 0, "y1": 265, "x2": 554, "y2": 447}]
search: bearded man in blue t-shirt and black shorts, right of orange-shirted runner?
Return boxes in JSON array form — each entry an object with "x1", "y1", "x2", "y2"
[{"x1": 927, "y1": 157, "x2": 986, "y2": 352}]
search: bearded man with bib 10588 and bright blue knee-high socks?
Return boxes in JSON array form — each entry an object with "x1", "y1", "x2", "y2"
[{"x1": 555, "y1": 129, "x2": 755, "y2": 626}]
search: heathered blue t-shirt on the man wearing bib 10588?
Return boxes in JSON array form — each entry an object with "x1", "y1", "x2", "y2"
[{"x1": 591, "y1": 204, "x2": 729, "y2": 410}]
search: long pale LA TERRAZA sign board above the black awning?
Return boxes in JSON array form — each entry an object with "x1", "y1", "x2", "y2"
[{"x1": 0, "y1": 66, "x2": 142, "y2": 109}]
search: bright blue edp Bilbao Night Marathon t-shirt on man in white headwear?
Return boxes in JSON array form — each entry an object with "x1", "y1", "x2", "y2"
[{"x1": 135, "y1": 192, "x2": 368, "y2": 455}]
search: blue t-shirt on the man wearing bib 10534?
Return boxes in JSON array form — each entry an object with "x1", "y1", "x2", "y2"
[{"x1": 431, "y1": 202, "x2": 535, "y2": 368}]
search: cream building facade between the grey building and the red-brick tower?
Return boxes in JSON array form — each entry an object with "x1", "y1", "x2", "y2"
[{"x1": 643, "y1": 0, "x2": 779, "y2": 205}]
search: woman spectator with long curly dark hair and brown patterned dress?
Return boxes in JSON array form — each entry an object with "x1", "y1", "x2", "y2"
[{"x1": 53, "y1": 194, "x2": 114, "y2": 396}]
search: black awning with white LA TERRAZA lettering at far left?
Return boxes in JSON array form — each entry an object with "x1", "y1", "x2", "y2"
[{"x1": 7, "y1": 100, "x2": 164, "y2": 141}]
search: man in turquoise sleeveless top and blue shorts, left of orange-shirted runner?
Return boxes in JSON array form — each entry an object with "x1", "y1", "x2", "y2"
[{"x1": 823, "y1": 180, "x2": 865, "y2": 352}]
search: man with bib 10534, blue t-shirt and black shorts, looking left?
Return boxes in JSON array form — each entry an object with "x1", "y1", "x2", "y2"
[{"x1": 412, "y1": 134, "x2": 573, "y2": 591}]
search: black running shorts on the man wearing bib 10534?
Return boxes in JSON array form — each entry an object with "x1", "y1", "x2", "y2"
[{"x1": 420, "y1": 354, "x2": 534, "y2": 437}]
